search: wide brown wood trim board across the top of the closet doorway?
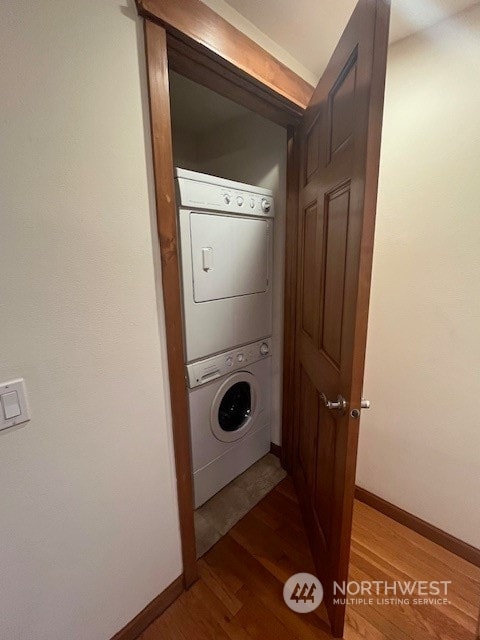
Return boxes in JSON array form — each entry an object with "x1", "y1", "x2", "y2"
[{"x1": 136, "y1": 0, "x2": 313, "y2": 109}]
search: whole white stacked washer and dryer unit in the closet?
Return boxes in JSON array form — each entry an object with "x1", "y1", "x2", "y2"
[{"x1": 175, "y1": 169, "x2": 274, "y2": 508}]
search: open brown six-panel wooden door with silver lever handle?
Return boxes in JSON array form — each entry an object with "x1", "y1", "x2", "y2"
[{"x1": 293, "y1": 0, "x2": 389, "y2": 637}]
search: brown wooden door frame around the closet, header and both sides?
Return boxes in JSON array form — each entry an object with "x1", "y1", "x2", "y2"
[{"x1": 137, "y1": 0, "x2": 313, "y2": 588}]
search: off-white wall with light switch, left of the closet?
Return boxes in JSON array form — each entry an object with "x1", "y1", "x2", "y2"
[{"x1": 0, "y1": 0, "x2": 181, "y2": 640}]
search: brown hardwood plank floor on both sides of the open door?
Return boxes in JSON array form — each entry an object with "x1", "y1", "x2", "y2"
[{"x1": 140, "y1": 478, "x2": 480, "y2": 640}]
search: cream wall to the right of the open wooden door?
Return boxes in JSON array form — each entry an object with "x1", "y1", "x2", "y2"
[{"x1": 357, "y1": 5, "x2": 480, "y2": 547}]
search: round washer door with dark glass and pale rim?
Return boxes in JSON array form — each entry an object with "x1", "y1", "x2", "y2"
[{"x1": 210, "y1": 371, "x2": 260, "y2": 442}]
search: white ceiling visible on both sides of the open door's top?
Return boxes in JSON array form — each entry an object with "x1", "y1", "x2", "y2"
[{"x1": 226, "y1": 0, "x2": 478, "y2": 78}]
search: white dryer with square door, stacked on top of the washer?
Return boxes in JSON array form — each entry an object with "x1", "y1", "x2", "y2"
[{"x1": 175, "y1": 169, "x2": 274, "y2": 362}]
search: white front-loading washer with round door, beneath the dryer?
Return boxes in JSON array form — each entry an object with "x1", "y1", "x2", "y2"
[{"x1": 187, "y1": 338, "x2": 272, "y2": 508}]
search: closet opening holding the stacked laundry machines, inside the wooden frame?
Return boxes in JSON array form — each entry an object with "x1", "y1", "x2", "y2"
[{"x1": 169, "y1": 70, "x2": 287, "y2": 557}]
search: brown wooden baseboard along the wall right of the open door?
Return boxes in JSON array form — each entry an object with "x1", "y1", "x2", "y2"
[{"x1": 355, "y1": 486, "x2": 480, "y2": 567}]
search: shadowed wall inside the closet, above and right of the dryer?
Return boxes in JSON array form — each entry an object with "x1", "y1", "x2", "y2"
[{"x1": 198, "y1": 113, "x2": 287, "y2": 444}]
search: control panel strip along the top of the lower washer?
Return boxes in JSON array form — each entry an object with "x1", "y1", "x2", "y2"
[{"x1": 186, "y1": 338, "x2": 272, "y2": 389}]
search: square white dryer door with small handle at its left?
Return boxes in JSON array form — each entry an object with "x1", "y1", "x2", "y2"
[{"x1": 190, "y1": 213, "x2": 271, "y2": 302}]
